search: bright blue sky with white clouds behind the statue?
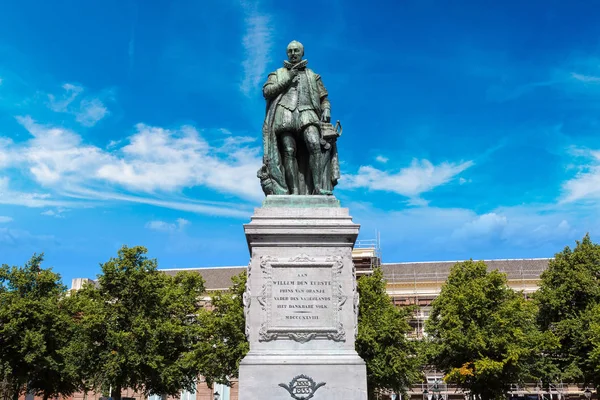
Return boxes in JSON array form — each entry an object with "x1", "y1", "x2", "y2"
[{"x1": 0, "y1": 0, "x2": 600, "y2": 284}]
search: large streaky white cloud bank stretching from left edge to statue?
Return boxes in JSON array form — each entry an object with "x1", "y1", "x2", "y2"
[{"x1": 0, "y1": 116, "x2": 263, "y2": 217}]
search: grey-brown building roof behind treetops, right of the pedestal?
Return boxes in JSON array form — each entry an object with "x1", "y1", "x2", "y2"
[{"x1": 381, "y1": 258, "x2": 551, "y2": 283}]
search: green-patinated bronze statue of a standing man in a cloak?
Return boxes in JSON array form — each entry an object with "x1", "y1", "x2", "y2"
[{"x1": 258, "y1": 41, "x2": 339, "y2": 195}]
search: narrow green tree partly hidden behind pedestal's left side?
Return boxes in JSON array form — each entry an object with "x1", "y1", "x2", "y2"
[{"x1": 194, "y1": 272, "x2": 250, "y2": 386}]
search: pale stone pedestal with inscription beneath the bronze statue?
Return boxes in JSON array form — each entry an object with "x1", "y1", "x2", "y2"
[{"x1": 239, "y1": 196, "x2": 367, "y2": 400}]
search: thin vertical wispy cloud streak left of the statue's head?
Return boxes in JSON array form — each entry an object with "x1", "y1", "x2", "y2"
[{"x1": 240, "y1": 10, "x2": 273, "y2": 95}]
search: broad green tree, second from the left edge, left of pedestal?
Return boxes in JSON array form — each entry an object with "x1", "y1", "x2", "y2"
[{"x1": 71, "y1": 246, "x2": 206, "y2": 400}]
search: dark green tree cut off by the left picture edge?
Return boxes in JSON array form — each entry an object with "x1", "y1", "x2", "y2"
[{"x1": 0, "y1": 255, "x2": 80, "y2": 399}]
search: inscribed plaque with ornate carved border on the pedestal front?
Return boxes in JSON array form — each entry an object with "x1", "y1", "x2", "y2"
[{"x1": 258, "y1": 255, "x2": 346, "y2": 342}]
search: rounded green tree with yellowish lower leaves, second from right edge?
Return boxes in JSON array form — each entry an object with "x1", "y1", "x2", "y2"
[{"x1": 426, "y1": 260, "x2": 541, "y2": 400}]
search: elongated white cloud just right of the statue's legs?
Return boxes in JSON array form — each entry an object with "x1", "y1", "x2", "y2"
[{"x1": 342, "y1": 159, "x2": 474, "y2": 198}]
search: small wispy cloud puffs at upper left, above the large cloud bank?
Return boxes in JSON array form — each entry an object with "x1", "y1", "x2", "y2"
[{"x1": 48, "y1": 83, "x2": 109, "y2": 127}]
